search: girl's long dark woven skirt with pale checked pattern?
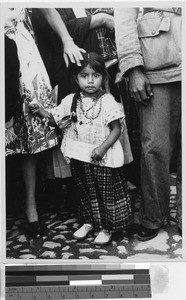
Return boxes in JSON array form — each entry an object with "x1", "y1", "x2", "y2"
[{"x1": 71, "y1": 159, "x2": 133, "y2": 232}]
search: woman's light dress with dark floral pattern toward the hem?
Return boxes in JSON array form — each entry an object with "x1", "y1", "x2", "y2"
[{"x1": 4, "y1": 8, "x2": 58, "y2": 155}]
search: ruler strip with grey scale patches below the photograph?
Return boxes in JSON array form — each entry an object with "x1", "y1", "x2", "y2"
[{"x1": 6, "y1": 264, "x2": 151, "y2": 300}]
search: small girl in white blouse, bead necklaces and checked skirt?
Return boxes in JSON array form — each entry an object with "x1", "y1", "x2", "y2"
[{"x1": 31, "y1": 53, "x2": 132, "y2": 245}]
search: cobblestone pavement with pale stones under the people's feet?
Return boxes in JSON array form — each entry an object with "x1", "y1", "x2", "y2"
[{"x1": 6, "y1": 176, "x2": 182, "y2": 261}]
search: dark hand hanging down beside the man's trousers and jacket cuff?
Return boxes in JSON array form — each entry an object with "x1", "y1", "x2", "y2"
[{"x1": 128, "y1": 67, "x2": 153, "y2": 105}]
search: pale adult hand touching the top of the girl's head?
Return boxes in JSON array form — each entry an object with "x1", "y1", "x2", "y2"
[{"x1": 63, "y1": 39, "x2": 86, "y2": 68}]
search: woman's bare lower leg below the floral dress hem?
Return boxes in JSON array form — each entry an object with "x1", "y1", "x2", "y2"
[{"x1": 22, "y1": 154, "x2": 38, "y2": 223}]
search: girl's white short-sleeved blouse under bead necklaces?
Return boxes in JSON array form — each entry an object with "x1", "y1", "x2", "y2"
[{"x1": 52, "y1": 93, "x2": 124, "y2": 168}]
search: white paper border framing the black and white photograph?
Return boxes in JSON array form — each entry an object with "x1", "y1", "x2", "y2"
[{"x1": 0, "y1": 1, "x2": 186, "y2": 264}]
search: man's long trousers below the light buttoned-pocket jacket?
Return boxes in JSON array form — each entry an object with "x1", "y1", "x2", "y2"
[{"x1": 140, "y1": 82, "x2": 181, "y2": 229}]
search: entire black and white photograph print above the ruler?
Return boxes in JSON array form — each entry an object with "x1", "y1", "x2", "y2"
[{"x1": 1, "y1": 1, "x2": 185, "y2": 263}]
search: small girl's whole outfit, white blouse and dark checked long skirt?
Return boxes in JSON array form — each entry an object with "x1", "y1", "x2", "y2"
[{"x1": 51, "y1": 94, "x2": 133, "y2": 232}]
